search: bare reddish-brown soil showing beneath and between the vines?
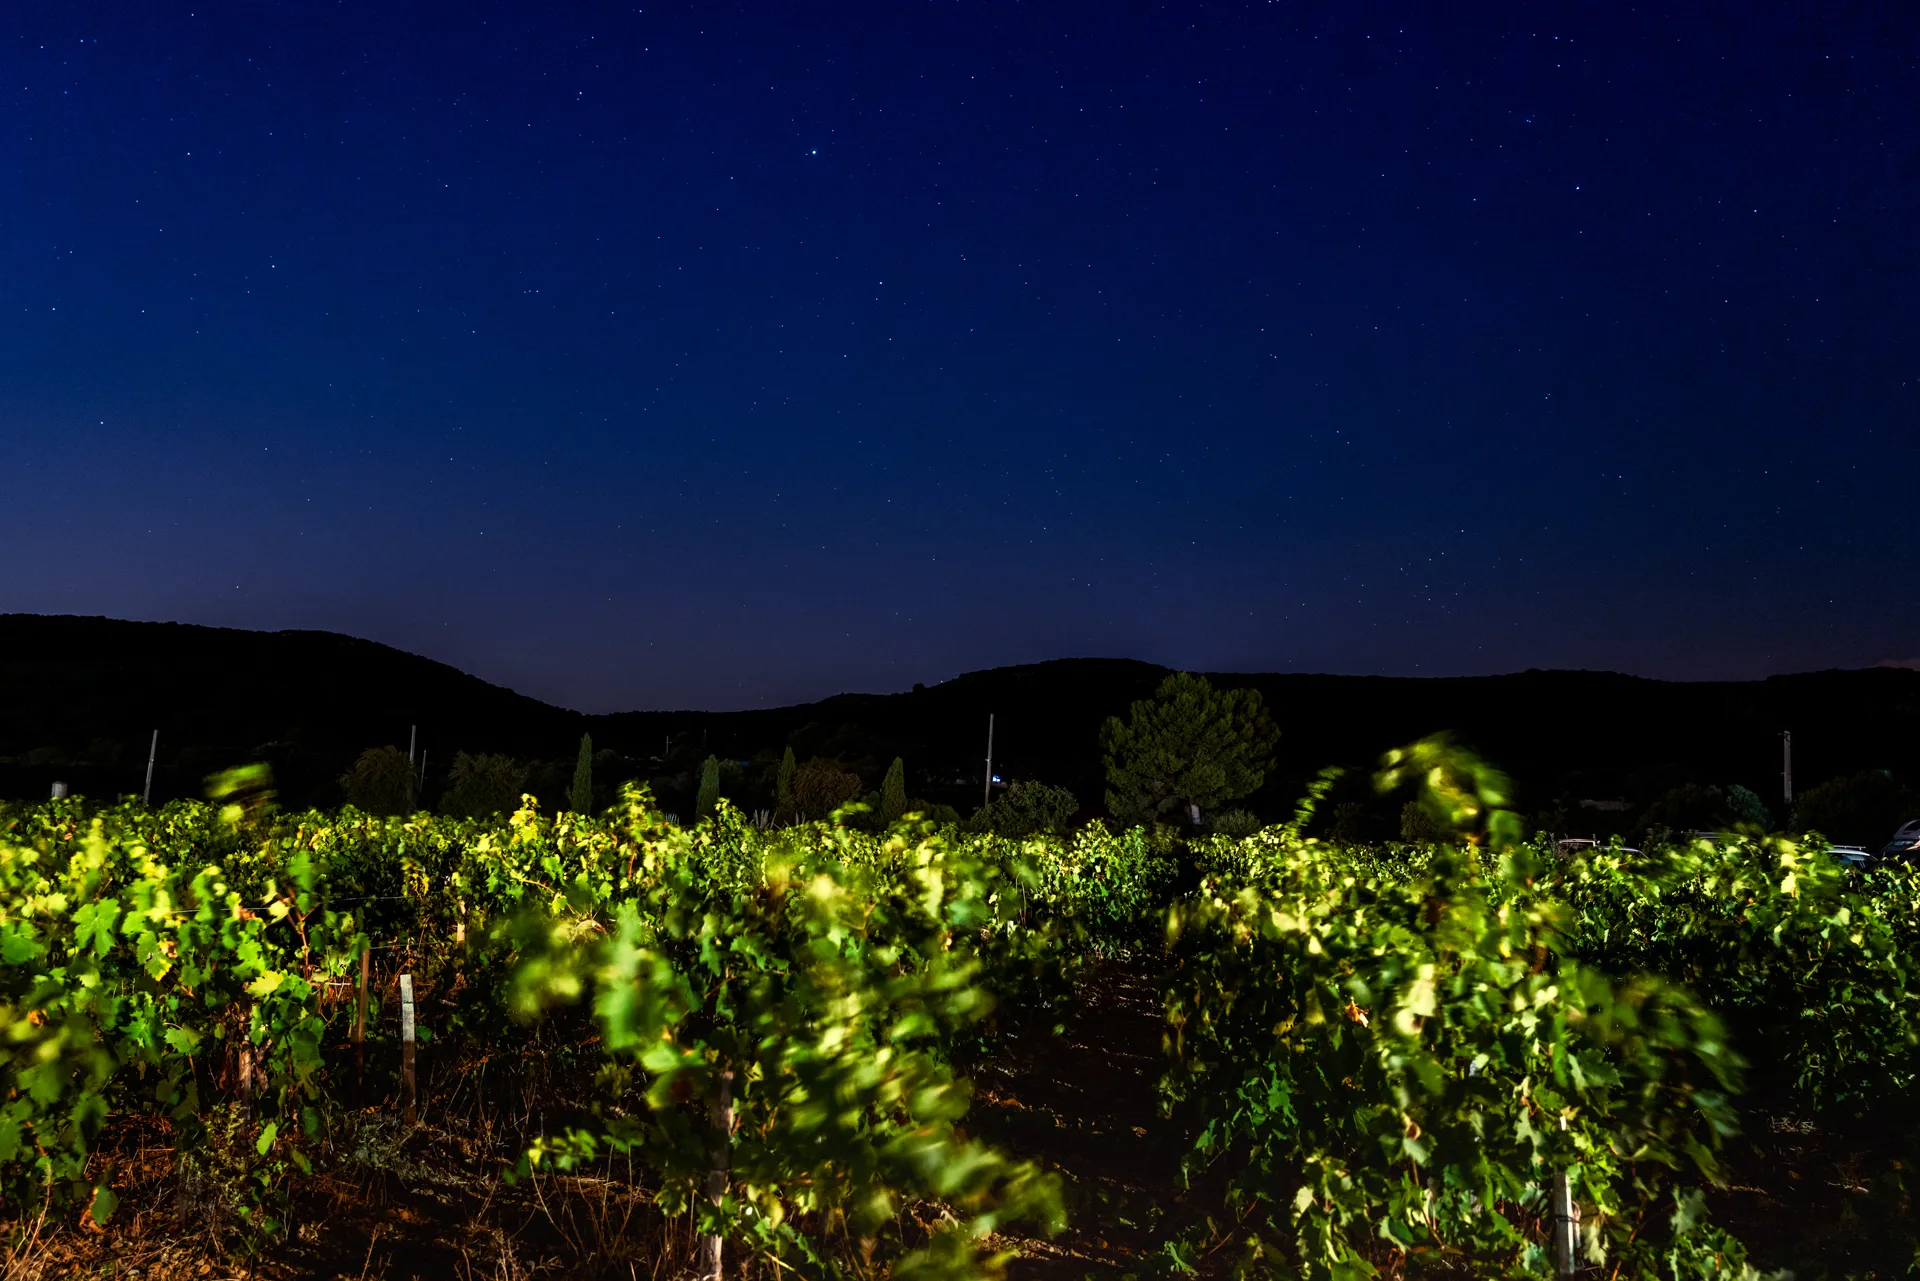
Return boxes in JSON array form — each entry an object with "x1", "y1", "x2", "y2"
[{"x1": 0, "y1": 964, "x2": 1912, "y2": 1281}]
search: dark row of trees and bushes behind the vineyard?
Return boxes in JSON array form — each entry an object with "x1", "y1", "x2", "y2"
[{"x1": 340, "y1": 672, "x2": 1920, "y2": 847}]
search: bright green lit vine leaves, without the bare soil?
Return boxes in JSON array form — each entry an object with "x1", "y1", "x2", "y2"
[{"x1": 0, "y1": 739, "x2": 1920, "y2": 1281}]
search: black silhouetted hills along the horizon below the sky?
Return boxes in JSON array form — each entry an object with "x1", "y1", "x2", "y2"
[{"x1": 0, "y1": 615, "x2": 1920, "y2": 814}]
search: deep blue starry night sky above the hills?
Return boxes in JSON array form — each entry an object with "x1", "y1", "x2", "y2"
[{"x1": 0, "y1": 0, "x2": 1920, "y2": 711}]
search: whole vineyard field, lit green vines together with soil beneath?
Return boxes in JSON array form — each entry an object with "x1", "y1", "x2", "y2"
[{"x1": 0, "y1": 743, "x2": 1920, "y2": 1281}]
